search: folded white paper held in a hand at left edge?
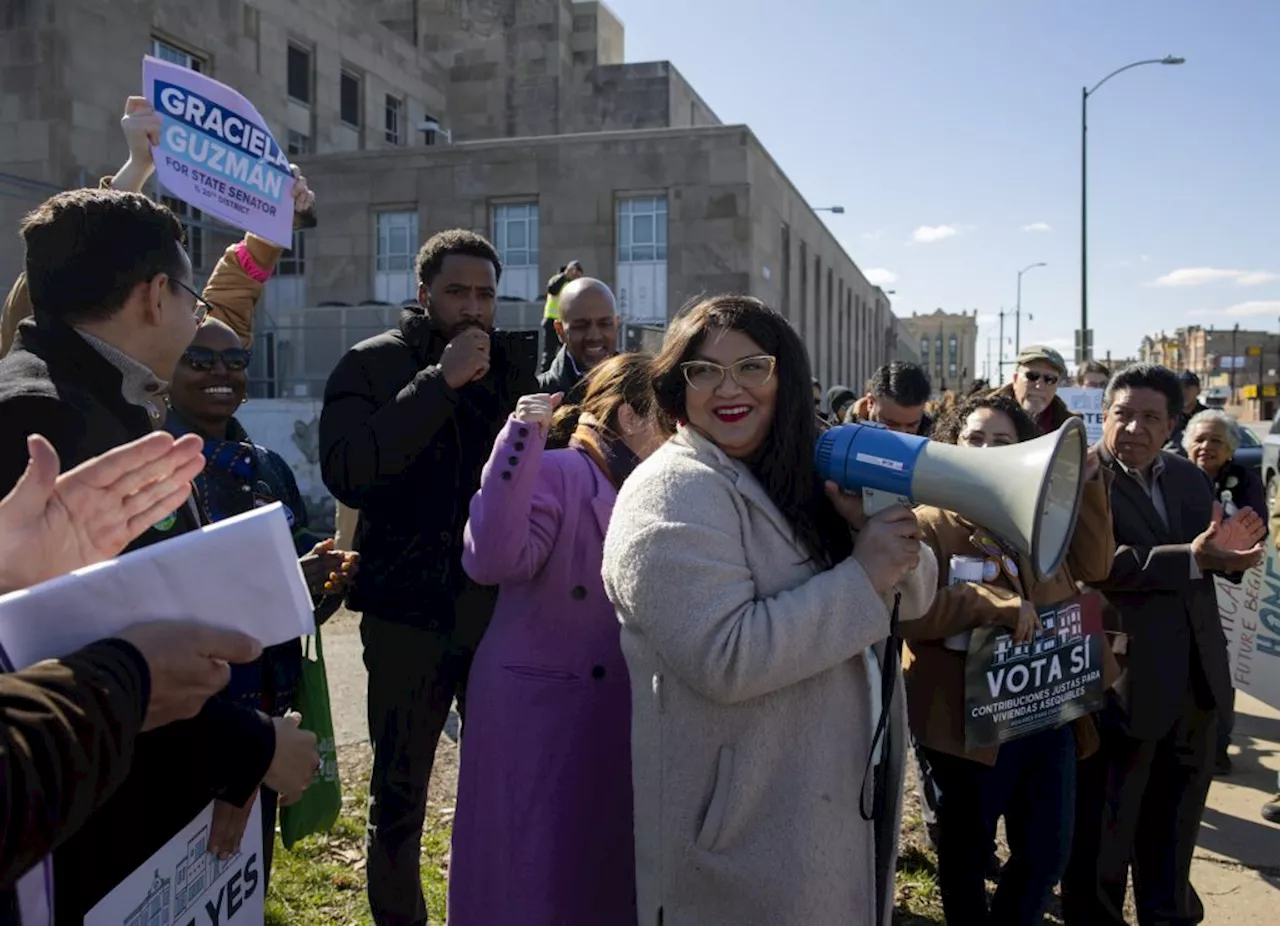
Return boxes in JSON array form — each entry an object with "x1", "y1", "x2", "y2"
[{"x1": 0, "y1": 503, "x2": 315, "y2": 669}]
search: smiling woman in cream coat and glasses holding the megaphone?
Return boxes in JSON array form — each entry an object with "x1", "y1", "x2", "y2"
[{"x1": 603, "y1": 296, "x2": 937, "y2": 926}]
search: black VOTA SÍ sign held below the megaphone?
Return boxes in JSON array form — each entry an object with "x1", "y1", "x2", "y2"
[{"x1": 964, "y1": 593, "x2": 1106, "y2": 751}]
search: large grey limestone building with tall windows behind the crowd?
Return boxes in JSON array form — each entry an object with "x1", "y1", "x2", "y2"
[{"x1": 0, "y1": 0, "x2": 896, "y2": 396}]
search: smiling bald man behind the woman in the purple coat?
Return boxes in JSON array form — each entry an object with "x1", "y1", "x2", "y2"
[{"x1": 538, "y1": 277, "x2": 618, "y2": 405}]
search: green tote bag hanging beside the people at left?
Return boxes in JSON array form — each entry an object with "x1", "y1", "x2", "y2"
[{"x1": 280, "y1": 626, "x2": 342, "y2": 849}]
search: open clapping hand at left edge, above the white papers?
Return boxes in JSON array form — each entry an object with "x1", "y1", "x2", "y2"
[{"x1": 0, "y1": 432, "x2": 205, "y2": 592}]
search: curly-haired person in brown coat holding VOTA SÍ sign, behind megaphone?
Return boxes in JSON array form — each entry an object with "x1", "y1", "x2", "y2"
[{"x1": 900, "y1": 393, "x2": 1117, "y2": 926}]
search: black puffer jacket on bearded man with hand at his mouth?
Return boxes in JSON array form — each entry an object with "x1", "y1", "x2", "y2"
[{"x1": 320, "y1": 309, "x2": 538, "y2": 631}]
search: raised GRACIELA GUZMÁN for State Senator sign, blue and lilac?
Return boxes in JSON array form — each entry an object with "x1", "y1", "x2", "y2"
[{"x1": 142, "y1": 55, "x2": 293, "y2": 247}]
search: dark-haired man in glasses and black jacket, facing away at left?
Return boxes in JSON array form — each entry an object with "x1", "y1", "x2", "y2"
[{"x1": 0, "y1": 190, "x2": 315, "y2": 922}]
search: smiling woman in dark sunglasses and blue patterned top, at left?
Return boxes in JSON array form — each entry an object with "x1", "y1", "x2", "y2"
[{"x1": 165, "y1": 318, "x2": 358, "y2": 876}]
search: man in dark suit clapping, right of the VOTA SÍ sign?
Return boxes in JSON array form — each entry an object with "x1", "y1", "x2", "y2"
[{"x1": 1062, "y1": 364, "x2": 1265, "y2": 926}]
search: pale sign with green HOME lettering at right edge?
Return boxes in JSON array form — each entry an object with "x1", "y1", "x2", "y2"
[{"x1": 1213, "y1": 538, "x2": 1280, "y2": 710}]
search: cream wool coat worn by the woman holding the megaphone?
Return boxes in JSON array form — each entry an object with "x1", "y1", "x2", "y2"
[{"x1": 603, "y1": 428, "x2": 937, "y2": 926}]
